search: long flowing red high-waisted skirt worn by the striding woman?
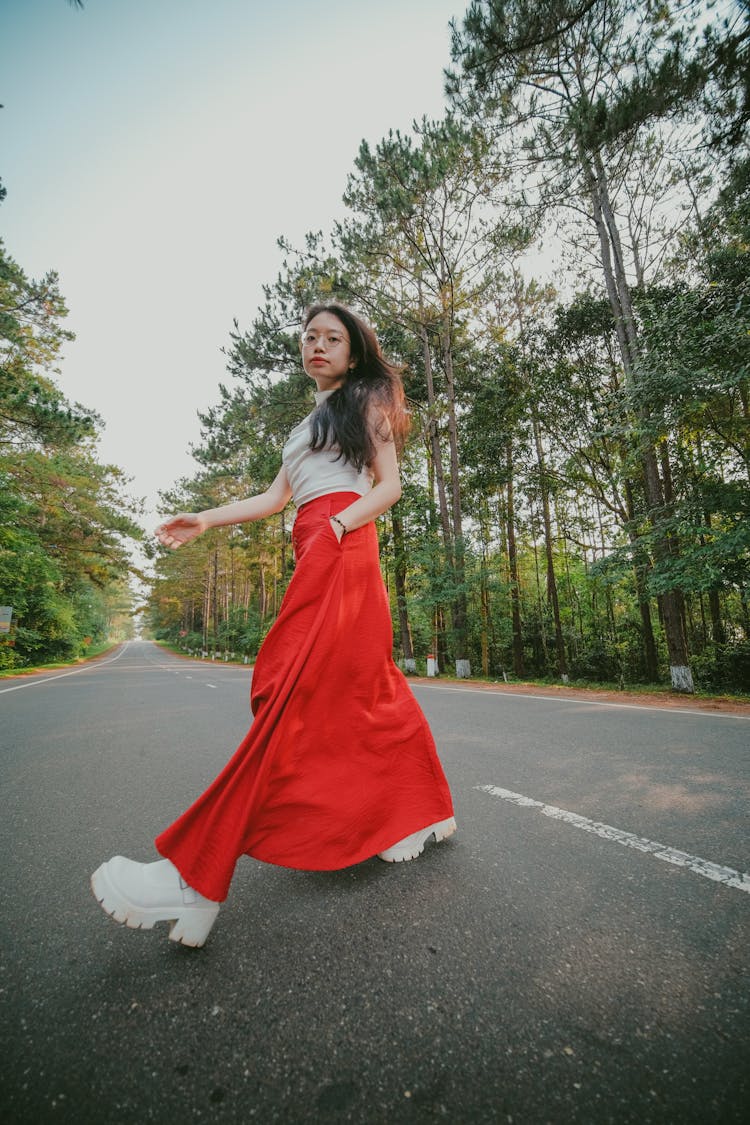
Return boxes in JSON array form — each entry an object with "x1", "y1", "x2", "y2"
[{"x1": 155, "y1": 493, "x2": 453, "y2": 902}]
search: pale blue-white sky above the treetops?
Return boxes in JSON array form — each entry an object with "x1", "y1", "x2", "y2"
[{"x1": 0, "y1": 0, "x2": 467, "y2": 528}]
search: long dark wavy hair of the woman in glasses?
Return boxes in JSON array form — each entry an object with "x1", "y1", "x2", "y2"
[{"x1": 302, "y1": 302, "x2": 409, "y2": 469}]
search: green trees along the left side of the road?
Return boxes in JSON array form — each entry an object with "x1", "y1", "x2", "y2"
[{"x1": 0, "y1": 214, "x2": 143, "y2": 672}]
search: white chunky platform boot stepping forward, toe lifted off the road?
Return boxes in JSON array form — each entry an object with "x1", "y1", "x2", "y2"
[{"x1": 91, "y1": 855, "x2": 219, "y2": 948}]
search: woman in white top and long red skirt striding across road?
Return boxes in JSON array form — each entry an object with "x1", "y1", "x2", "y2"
[{"x1": 91, "y1": 304, "x2": 455, "y2": 946}]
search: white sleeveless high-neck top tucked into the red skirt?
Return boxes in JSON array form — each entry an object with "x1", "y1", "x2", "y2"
[{"x1": 281, "y1": 387, "x2": 372, "y2": 507}]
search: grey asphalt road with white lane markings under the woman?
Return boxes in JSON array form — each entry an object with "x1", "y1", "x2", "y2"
[{"x1": 0, "y1": 644, "x2": 750, "y2": 1125}]
